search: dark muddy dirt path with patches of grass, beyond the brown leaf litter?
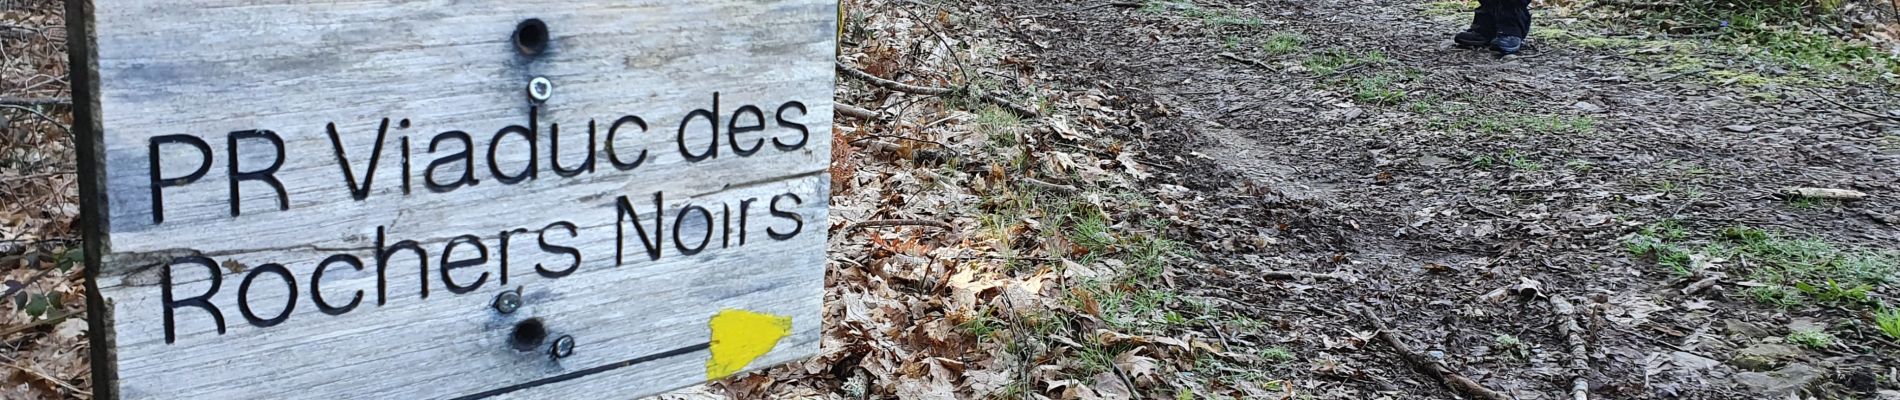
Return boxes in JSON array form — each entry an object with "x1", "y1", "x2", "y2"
[{"x1": 994, "y1": 0, "x2": 1900, "y2": 398}]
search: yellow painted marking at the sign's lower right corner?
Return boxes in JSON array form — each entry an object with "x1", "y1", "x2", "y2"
[{"x1": 707, "y1": 309, "x2": 792, "y2": 379}]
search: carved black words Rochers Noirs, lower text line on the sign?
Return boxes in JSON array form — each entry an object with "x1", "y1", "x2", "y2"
[{"x1": 160, "y1": 191, "x2": 806, "y2": 343}]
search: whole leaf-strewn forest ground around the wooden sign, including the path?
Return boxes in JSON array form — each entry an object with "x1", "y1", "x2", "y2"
[{"x1": 0, "y1": 0, "x2": 1900, "y2": 400}]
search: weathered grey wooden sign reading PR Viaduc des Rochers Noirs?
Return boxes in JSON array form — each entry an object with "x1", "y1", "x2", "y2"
[{"x1": 67, "y1": 0, "x2": 836, "y2": 398}]
